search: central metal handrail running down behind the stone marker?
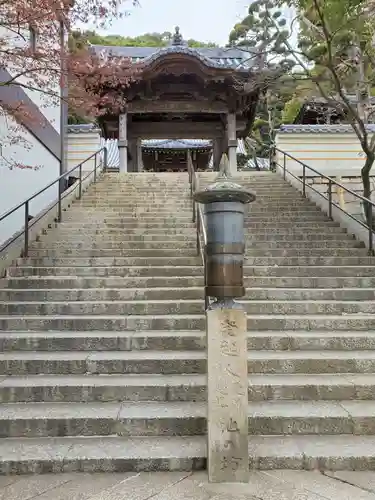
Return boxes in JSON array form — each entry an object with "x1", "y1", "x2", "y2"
[{"x1": 187, "y1": 156, "x2": 209, "y2": 309}]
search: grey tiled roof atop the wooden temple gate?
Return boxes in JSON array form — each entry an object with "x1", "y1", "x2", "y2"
[{"x1": 92, "y1": 45, "x2": 255, "y2": 70}]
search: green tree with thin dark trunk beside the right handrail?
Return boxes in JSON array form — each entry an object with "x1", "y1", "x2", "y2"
[{"x1": 230, "y1": 0, "x2": 375, "y2": 222}]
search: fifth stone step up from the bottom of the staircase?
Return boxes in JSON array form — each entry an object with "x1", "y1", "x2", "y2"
[{"x1": 0, "y1": 330, "x2": 375, "y2": 355}]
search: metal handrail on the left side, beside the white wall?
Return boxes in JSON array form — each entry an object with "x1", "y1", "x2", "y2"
[{"x1": 0, "y1": 147, "x2": 108, "y2": 258}]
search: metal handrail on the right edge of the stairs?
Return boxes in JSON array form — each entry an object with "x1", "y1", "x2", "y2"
[{"x1": 273, "y1": 147, "x2": 375, "y2": 254}]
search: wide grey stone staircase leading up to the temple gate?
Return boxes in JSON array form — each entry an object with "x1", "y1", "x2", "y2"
[{"x1": 0, "y1": 172, "x2": 375, "y2": 473}]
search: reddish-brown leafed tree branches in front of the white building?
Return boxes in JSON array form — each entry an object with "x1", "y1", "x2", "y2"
[{"x1": 0, "y1": 0, "x2": 139, "y2": 167}]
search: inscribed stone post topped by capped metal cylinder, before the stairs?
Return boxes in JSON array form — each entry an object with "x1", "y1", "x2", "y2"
[{"x1": 195, "y1": 157, "x2": 255, "y2": 482}]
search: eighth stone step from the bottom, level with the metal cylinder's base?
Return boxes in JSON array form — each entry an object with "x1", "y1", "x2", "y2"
[{"x1": 0, "y1": 282, "x2": 375, "y2": 302}]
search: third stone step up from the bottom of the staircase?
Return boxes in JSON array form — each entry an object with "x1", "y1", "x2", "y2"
[{"x1": 0, "y1": 373, "x2": 375, "y2": 403}]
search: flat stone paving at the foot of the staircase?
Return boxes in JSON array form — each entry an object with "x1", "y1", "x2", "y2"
[{"x1": 0, "y1": 470, "x2": 375, "y2": 500}]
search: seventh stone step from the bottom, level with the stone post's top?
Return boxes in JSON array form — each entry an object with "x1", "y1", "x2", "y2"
[{"x1": 0, "y1": 299, "x2": 375, "y2": 314}]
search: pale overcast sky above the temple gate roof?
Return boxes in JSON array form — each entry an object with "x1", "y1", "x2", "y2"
[{"x1": 103, "y1": 0, "x2": 250, "y2": 46}]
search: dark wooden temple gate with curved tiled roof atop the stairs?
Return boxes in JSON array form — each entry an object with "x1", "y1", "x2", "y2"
[{"x1": 92, "y1": 28, "x2": 261, "y2": 173}]
